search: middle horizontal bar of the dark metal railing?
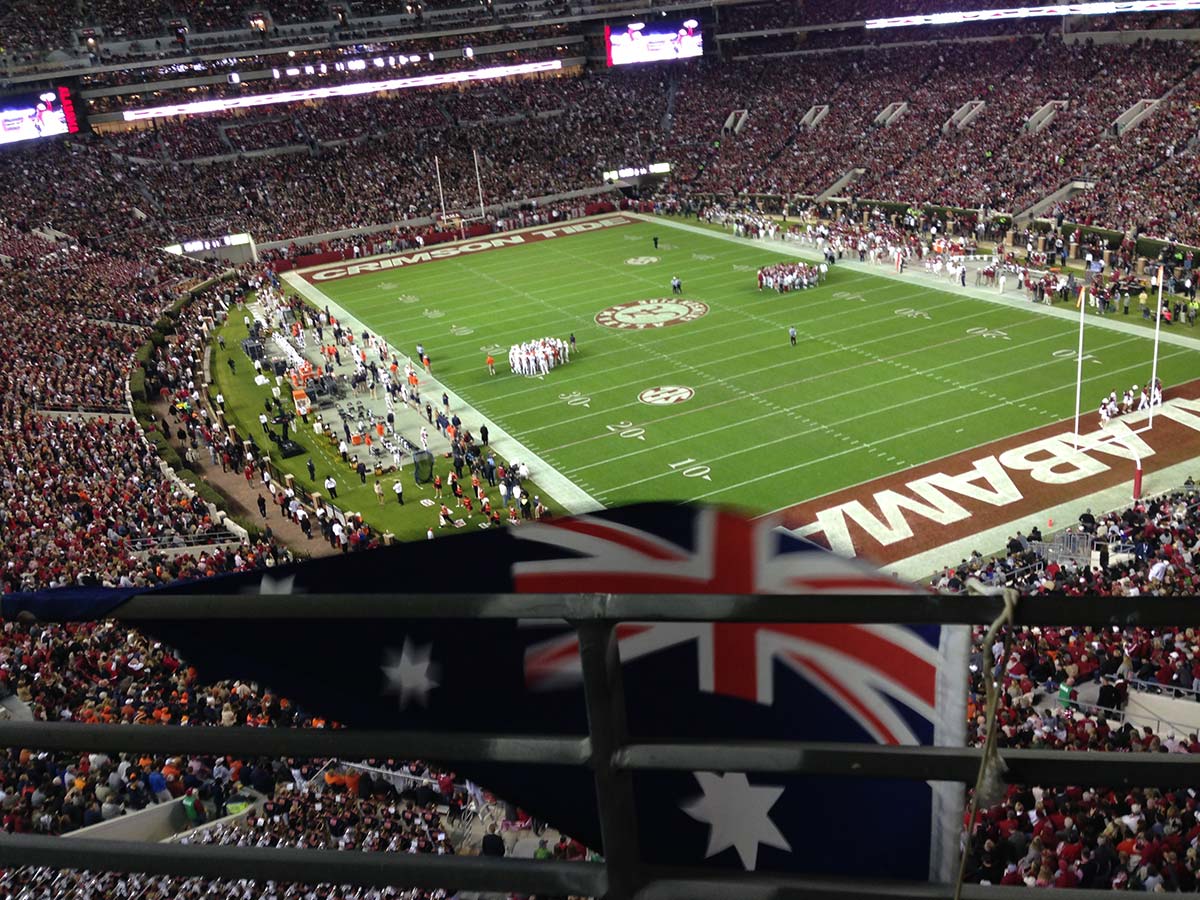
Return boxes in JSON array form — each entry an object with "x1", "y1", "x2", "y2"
[{"x1": 0, "y1": 721, "x2": 1195, "y2": 787}]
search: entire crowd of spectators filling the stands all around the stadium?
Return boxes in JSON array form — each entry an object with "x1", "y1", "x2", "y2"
[{"x1": 0, "y1": 7, "x2": 1200, "y2": 900}]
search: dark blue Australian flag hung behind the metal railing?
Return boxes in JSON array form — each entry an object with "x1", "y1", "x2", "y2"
[{"x1": 4, "y1": 504, "x2": 968, "y2": 881}]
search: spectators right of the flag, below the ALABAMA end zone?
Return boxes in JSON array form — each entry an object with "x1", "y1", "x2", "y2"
[{"x1": 945, "y1": 485, "x2": 1200, "y2": 892}]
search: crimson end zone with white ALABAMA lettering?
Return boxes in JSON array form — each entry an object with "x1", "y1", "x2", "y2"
[{"x1": 775, "y1": 380, "x2": 1200, "y2": 565}]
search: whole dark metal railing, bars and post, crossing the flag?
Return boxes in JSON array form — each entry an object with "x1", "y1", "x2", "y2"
[{"x1": 0, "y1": 594, "x2": 1200, "y2": 900}]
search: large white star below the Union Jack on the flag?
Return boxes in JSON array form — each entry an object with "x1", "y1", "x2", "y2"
[{"x1": 680, "y1": 772, "x2": 792, "y2": 871}]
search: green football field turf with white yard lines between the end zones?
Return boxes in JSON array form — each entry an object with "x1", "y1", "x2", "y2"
[{"x1": 295, "y1": 217, "x2": 1196, "y2": 520}]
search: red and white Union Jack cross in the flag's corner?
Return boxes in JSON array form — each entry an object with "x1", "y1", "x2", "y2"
[{"x1": 514, "y1": 509, "x2": 942, "y2": 744}]
